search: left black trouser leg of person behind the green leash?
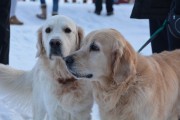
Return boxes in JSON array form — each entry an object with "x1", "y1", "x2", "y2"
[{"x1": 149, "y1": 19, "x2": 169, "y2": 53}]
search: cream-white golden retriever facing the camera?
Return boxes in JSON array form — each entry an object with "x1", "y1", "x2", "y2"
[{"x1": 0, "y1": 15, "x2": 93, "y2": 120}]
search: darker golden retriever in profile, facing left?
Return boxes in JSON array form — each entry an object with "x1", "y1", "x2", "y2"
[{"x1": 65, "y1": 29, "x2": 180, "y2": 120}]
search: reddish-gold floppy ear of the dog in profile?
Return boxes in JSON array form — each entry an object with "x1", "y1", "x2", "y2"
[{"x1": 112, "y1": 40, "x2": 136, "y2": 84}]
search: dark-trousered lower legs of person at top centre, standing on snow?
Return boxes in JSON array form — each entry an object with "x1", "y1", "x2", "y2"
[{"x1": 94, "y1": 0, "x2": 114, "y2": 16}]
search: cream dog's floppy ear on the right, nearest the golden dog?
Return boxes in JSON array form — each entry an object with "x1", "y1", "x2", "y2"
[{"x1": 76, "y1": 26, "x2": 84, "y2": 50}]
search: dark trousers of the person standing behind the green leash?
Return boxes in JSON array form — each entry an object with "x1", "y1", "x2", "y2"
[{"x1": 149, "y1": 19, "x2": 180, "y2": 53}]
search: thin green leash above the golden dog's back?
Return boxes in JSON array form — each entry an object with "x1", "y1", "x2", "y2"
[{"x1": 138, "y1": 20, "x2": 167, "y2": 53}]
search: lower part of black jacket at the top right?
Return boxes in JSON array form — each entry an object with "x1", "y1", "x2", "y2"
[{"x1": 131, "y1": 0, "x2": 172, "y2": 19}]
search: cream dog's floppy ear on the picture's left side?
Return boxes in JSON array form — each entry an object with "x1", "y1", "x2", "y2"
[{"x1": 36, "y1": 27, "x2": 45, "y2": 57}]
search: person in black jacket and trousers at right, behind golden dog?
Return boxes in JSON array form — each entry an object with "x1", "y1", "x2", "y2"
[{"x1": 131, "y1": 0, "x2": 180, "y2": 53}]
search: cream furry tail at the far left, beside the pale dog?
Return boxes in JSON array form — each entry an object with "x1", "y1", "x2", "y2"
[{"x1": 0, "y1": 64, "x2": 33, "y2": 117}]
